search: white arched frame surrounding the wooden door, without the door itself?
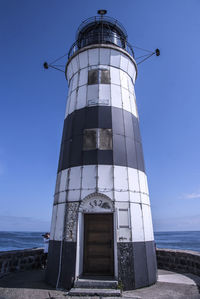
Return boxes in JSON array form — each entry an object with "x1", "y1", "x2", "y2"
[{"x1": 75, "y1": 194, "x2": 118, "y2": 280}]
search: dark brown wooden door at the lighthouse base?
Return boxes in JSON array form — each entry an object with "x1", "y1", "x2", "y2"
[{"x1": 83, "y1": 214, "x2": 114, "y2": 276}]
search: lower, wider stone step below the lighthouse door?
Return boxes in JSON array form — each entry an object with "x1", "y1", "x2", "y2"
[{"x1": 68, "y1": 288, "x2": 121, "y2": 297}]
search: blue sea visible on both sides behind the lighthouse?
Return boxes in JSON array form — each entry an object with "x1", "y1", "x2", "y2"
[{"x1": 0, "y1": 231, "x2": 200, "y2": 252}]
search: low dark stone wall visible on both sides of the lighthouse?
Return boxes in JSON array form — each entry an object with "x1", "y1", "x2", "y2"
[{"x1": 0, "y1": 248, "x2": 200, "y2": 277}]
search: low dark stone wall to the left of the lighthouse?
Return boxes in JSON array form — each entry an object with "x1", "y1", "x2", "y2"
[{"x1": 0, "y1": 248, "x2": 43, "y2": 277}]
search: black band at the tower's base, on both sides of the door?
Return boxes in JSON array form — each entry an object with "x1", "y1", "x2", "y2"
[{"x1": 46, "y1": 241, "x2": 157, "y2": 290}]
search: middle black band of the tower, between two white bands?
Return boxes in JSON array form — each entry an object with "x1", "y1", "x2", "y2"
[{"x1": 58, "y1": 106, "x2": 145, "y2": 172}]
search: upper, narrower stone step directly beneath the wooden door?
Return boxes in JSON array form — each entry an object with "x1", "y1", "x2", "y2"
[{"x1": 74, "y1": 278, "x2": 118, "y2": 289}]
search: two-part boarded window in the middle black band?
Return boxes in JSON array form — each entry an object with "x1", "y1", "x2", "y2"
[{"x1": 83, "y1": 129, "x2": 112, "y2": 151}]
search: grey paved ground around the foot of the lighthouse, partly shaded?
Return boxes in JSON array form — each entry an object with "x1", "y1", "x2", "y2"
[{"x1": 0, "y1": 270, "x2": 200, "y2": 299}]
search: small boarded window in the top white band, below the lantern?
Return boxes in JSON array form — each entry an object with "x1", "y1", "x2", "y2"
[{"x1": 88, "y1": 69, "x2": 110, "y2": 85}]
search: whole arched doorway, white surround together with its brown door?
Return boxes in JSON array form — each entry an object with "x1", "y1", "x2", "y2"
[{"x1": 76, "y1": 193, "x2": 117, "y2": 277}]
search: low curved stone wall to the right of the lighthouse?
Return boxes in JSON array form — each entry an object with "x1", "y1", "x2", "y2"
[{"x1": 156, "y1": 249, "x2": 200, "y2": 276}]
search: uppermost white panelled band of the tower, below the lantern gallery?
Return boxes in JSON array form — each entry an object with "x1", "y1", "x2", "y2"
[{"x1": 65, "y1": 46, "x2": 137, "y2": 117}]
